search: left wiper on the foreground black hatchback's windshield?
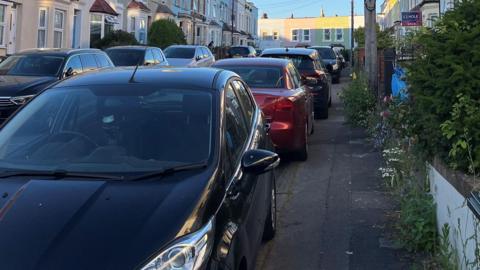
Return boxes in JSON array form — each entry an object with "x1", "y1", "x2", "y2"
[{"x1": 0, "y1": 170, "x2": 124, "y2": 180}]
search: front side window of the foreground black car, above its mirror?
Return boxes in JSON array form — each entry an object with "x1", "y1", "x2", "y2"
[{"x1": 225, "y1": 84, "x2": 248, "y2": 169}]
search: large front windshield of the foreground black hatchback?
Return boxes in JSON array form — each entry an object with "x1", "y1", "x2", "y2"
[{"x1": 0, "y1": 85, "x2": 214, "y2": 173}]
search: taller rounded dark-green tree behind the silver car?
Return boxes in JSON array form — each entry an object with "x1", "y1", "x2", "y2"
[{"x1": 148, "y1": 19, "x2": 186, "y2": 48}]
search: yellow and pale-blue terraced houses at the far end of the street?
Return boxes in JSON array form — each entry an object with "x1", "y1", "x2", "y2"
[{"x1": 258, "y1": 12, "x2": 364, "y2": 49}]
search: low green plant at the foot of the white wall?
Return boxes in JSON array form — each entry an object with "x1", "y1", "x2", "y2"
[{"x1": 398, "y1": 188, "x2": 437, "y2": 252}]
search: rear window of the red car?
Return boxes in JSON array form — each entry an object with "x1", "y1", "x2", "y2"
[{"x1": 220, "y1": 66, "x2": 284, "y2": 88}]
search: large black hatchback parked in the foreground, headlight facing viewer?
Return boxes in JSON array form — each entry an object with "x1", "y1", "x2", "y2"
[{"x1": 0, "y1": 68, "x2": 279, "y2": 270}]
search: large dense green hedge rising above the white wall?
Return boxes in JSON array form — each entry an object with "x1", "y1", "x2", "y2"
[{"x1": 407, "y1": 0, "x2": 480, "y2": 173}]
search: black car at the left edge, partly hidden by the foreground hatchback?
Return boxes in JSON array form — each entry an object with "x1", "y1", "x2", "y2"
[{"x1": 0, "y1": 49, "x2": 113, "y2": 122}]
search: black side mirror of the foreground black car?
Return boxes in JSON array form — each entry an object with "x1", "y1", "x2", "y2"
[{"x1": 242, "y1": 149, "x2": 280, "y2": 174}]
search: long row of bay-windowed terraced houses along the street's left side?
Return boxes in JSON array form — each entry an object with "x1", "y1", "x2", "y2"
[{"x1": 0, "y1": 0, "x2": 258, "y2": 56}]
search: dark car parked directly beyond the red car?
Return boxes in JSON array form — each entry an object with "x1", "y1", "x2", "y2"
[{"x1": 262, "y1": 48, "x2": 332, "y2": 119}]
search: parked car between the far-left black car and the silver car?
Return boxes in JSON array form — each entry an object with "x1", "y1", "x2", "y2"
[{"x1": 105, "y1": 46, "x2": 168, "y2": 67}]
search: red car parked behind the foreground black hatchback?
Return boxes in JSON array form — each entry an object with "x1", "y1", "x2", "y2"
[{"x1": 213, "y1": 58, "x2": 314, "y2": 160}]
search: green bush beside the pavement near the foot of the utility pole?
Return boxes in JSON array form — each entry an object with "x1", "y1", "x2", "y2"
[{"x1": 340, "y1": 74, "x2": 376, "y2": 128}]
